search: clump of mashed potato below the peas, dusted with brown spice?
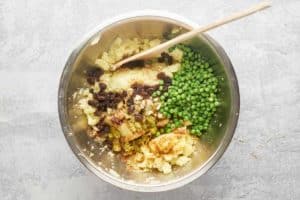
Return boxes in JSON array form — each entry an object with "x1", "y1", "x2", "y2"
[{"x1": 127, "y1": 130, "x2": 195, "y2": 174}]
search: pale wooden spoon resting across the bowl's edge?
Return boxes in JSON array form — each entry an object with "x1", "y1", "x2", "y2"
[{"x1": 112, "y1": 1, "x2": 271, "y2": 70}]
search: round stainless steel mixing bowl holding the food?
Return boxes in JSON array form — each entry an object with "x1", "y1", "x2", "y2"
[{"x1": 58, "y1": 11, "x2": 239, "y2": 192}]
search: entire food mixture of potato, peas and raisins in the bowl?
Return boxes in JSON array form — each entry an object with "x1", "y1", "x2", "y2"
[{"x1": 74, "y1": 32, "x2": 220, "y2": 174}]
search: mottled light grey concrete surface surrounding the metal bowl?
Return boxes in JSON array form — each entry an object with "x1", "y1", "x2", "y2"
[{"x1": 0, "y1": 0, "x2": 300, "y2": 200}]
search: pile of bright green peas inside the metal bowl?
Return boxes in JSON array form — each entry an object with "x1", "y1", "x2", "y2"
[{"x1": 153, "y1": 44, "x2": 220, "y2": 136}]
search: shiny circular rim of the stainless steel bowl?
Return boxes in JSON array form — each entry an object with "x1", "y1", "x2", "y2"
[{"x1": 58, "y1": 10, "x2": 240, "y2": 192}]
